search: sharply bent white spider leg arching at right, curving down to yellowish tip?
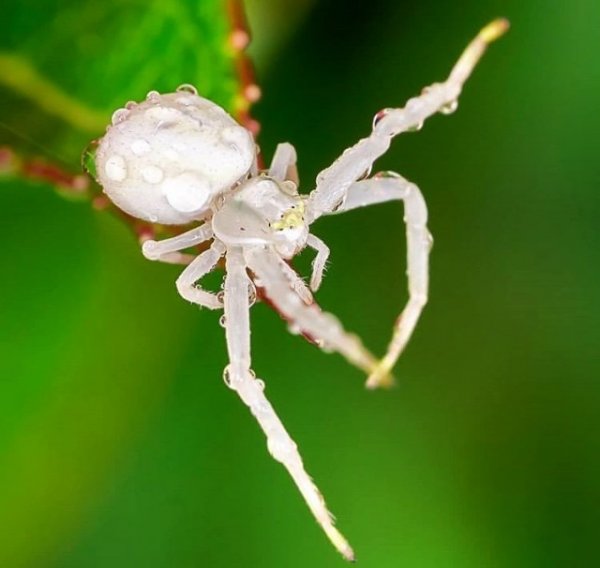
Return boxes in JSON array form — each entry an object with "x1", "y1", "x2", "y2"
[{"x1": 326, "y1": 172, "x2": 433, "y2": 388}]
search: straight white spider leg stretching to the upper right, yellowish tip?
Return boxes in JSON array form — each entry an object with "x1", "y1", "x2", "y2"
[{"x1": 306, "y1": 19, "x2": 508, "y2": 224}]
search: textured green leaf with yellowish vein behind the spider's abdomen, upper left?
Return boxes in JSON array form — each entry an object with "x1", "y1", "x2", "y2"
[{"x1": 0, "y1": 0, "x2": 239, "y2": 171}]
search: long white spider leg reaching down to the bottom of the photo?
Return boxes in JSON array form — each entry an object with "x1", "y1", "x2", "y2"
[{"x1": 224, "y1": 247, "x2": 354, "y2": 560}]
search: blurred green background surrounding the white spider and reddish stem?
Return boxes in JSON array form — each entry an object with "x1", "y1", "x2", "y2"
[{"x1": 0, "y1": 0, "x2": 600, "y2": 568}]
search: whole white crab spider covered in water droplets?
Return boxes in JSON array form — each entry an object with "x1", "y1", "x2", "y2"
[{"x1": 96, "y1": 20, "x2": 508, "y2": 560}]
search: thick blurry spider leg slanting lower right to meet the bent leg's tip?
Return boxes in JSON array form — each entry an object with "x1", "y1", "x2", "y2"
[{"x1": 246, "y1": 249, "x2": 392, "y2": 384}]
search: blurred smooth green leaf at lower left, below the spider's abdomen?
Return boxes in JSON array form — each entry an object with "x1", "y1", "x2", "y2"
[{"x1": 0, "y1": 175, "x2": 203, "y2": 568}]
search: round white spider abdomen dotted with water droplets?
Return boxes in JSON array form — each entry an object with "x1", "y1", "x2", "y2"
[{"x1": 96, "y1": 87, "x2": 256, "y2": 224}]
